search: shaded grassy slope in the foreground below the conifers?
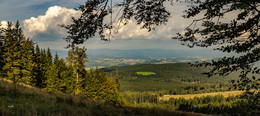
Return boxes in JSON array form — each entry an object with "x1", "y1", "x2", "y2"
[{"x1": 0, "y1": 79, "x2": 208, "y2": 116}]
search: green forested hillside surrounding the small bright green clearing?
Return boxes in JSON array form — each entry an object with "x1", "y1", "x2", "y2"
[{"x1": 100, "y1": 63, "x2": 241, "y2": 95}]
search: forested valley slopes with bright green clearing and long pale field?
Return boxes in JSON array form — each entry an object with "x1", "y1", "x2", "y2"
[{"x1": 100, "y1": 63, "x2": 258, "y2": 115}]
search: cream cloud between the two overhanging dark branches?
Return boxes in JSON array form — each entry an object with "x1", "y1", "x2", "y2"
[{"x1": 103, "y1": 3, "x2": 192, "y2": 39}]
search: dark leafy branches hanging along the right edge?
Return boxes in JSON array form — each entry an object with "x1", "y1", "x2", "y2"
[{"x1": 174, "y1": 0, "x2": 260, "y2": 90}]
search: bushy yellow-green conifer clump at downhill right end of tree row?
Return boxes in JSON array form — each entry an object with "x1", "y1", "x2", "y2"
[{"x1": 82, "y1": 69, "x2": 124, "y2": 105}]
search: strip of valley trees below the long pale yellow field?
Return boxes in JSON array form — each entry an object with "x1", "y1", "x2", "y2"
[{"x1": 122, "y1": 91, "x2": 259, "y2": 116}]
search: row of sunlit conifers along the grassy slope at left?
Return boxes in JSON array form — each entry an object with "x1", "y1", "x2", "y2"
[{"x1": 0, "y1": 21, "x2": 124, "y2": 104}]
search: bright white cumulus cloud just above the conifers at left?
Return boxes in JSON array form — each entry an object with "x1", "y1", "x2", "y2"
[{"x1": 23, "y1": 6, "x2": 80, "y2": 41}]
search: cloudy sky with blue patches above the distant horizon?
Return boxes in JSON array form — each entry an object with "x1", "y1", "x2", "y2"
[{"x1": 0, "y1": 0, "x2": 209, "y2": 50}]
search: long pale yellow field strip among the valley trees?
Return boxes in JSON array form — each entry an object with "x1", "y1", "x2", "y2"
[{"x1": 159, "y1": 91, "x2": 243, "y2": 100}]
